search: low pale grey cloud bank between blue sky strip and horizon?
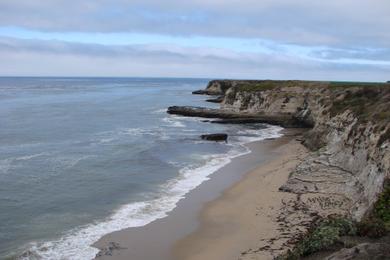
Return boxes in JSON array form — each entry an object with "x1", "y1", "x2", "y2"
[{"x1": 0, "y1": 37, "x2": 390, "y2": 81}]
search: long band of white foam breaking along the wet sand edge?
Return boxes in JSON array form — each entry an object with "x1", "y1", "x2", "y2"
[{"x1": 20, "y1": 126, "x2": 282, "y2": 259}]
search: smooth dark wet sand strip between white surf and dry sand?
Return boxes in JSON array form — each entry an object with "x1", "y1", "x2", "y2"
[{"x1": 93, "y1": 129, "x2": 301, "y2": 260}]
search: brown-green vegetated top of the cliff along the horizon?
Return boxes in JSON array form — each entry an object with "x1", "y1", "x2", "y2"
[{"x1": 213, "y1": 80, "x2": 390, "y2": 124}]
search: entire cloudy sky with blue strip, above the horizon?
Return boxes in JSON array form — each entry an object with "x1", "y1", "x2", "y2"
[{"x1": 0, "y1": 0, "x2": 390, "y2": 81}]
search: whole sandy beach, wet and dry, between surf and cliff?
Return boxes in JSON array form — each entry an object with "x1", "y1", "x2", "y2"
[{"x1": 94, "y1": 130, "x2": 305, "y2": 260}]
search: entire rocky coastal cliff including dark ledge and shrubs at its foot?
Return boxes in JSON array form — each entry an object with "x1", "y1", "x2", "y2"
[{"x1": 168, "y1": 80, "x2": 390, "y2": 260}]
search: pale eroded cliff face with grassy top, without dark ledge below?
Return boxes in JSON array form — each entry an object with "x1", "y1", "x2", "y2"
[{"x1": 221, "y1": 81, "x2": 390, "y2": 220}]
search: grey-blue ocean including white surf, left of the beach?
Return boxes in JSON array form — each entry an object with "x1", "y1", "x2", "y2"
[{"x1": 0, "y1": 78, "x2": 281, "y2": 259}]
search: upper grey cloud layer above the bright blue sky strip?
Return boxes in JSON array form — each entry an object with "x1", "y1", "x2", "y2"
[{"x1": 0, "y1": 0, "x2": 390, "y2": 48}]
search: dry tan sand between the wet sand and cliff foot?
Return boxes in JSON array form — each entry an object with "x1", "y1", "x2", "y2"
[{"x1": 173, "y1": 140, "x2": 307, "y2": 260}]
